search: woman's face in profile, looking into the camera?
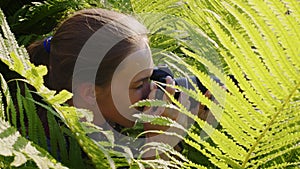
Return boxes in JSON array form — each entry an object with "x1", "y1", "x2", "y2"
[{"x1": 95, "y1": 45, "x2": 153, "y2": 127}]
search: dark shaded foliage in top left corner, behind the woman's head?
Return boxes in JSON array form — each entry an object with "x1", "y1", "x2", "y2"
[{"x1": 0, "y1": 0, "x2": 103, "y2": 46}]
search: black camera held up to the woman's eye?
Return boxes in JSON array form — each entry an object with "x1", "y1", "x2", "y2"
[{"x1": 150, "y1": 65, "x2": 207, "y2": 99}]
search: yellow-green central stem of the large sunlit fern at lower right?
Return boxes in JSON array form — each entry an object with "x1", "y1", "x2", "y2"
[{"x1": 242, "y1": 82, "x2": 300, "y2": 168}]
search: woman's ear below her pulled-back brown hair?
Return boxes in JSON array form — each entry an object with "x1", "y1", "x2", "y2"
[{"x1": 73, "y1": 83, "x2": 97, "y2": 108}]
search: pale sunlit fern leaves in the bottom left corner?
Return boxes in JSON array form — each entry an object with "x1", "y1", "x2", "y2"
[{"x1": 0, "y1": 75, "x2": 65, "y2": 168}]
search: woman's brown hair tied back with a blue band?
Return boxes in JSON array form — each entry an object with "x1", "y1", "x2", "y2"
[{"x1": 28, "y1": 9, "x2": 147, "y2": 91}]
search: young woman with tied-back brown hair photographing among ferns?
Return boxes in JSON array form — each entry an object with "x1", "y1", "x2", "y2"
[{"x1": 28, "y1": 9, "x2": 211, "y2": 157}]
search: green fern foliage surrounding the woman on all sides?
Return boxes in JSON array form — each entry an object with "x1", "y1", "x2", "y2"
[{"x1": 0, "y1": 0, "x2": 300, "y2": 168}]
